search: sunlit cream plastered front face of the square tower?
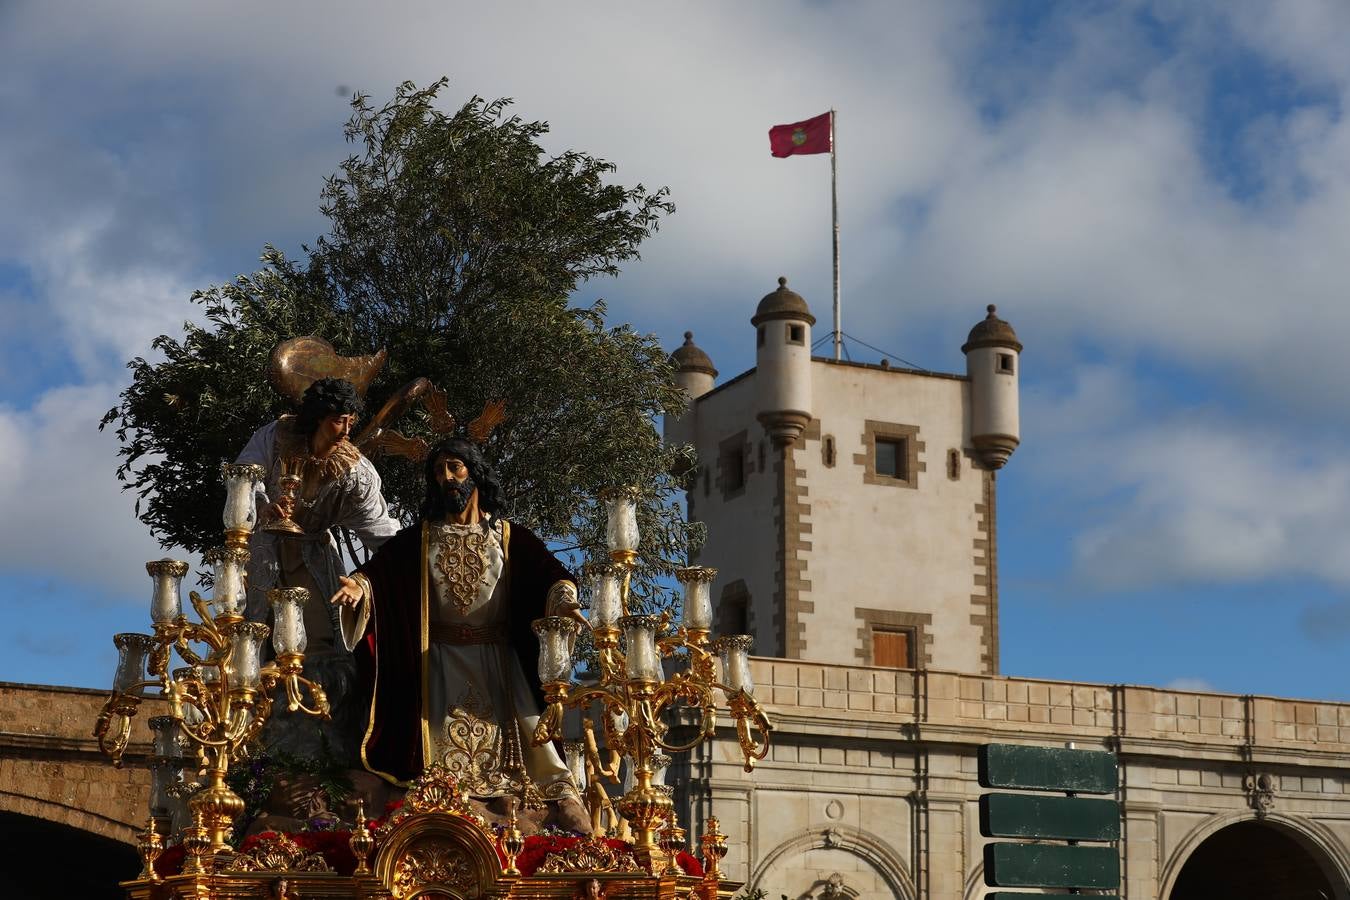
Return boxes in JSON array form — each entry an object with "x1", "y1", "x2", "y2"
[{"x1": 797, "y1": 360, "x2": 986, "y2": 672}]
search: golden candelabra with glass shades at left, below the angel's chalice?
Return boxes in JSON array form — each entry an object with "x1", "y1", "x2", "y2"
[{"x1": 95, "y1": 466, "x2": 328, "y2": 873}]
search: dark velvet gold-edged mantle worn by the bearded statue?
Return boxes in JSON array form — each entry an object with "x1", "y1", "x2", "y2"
[{"x1": 356, "y1": 522, "x2": 575, "y2": 784}]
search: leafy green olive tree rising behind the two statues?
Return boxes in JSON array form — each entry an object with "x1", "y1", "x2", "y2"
[{"x1": 103, "y1": 80, "x2": 698, "y2": 600}]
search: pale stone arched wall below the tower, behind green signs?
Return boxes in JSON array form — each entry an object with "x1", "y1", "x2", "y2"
[{"x1": 676, "y1": 660, "x2": 1350, "y2": 900}]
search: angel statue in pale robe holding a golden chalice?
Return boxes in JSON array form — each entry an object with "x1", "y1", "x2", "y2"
[{"x1": 236, "y1": 336, "x2": 452, "y2": 768}]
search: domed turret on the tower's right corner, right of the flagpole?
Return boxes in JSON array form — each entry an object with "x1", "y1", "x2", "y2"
[{"x1": 961, "y1": 304, "x2": 1022, "y2": 468}]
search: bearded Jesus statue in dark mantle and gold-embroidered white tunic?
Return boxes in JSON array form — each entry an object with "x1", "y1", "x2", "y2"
[{"x1": 331, "y1": 437, "x2": 589, "y2": 830}]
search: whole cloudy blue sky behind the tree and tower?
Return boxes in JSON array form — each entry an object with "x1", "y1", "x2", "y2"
[{"x1": 0, "y1": 0, "x2": 1350, "y2": 700}]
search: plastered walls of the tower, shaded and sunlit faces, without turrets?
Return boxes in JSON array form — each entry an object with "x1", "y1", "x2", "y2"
[{"x1": 682, "y1": 361, "x2": 994, "y2": 672}]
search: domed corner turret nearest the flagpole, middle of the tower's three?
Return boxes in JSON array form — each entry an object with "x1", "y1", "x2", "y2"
[{"x1": 751, "y1": 272, "x2": 815, "y2": 447}]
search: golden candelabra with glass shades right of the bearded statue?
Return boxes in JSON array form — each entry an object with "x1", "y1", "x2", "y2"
[{"x1": 533, "y1": 490, "x2": 772, "y2": 870}]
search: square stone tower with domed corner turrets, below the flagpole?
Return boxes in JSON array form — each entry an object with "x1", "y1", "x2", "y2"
[{"x1": 666, "y1": 278, "x2": 1022, "y2": 673}]
